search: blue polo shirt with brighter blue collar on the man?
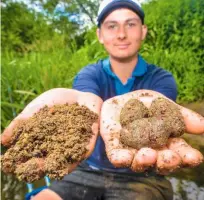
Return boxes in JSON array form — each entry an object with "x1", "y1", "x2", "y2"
[{"x1": 73, "y1": 56, "x2": 177, "y2": 173}]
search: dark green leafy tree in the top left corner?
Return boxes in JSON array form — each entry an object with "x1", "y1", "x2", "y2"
[{"x1": 1, "y1": 2, "x2": 49, "y2": 51}]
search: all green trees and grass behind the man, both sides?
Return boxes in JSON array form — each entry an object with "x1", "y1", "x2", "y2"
[{"x1": 1, "y1": 0, "x2": 204, "y2": 199}]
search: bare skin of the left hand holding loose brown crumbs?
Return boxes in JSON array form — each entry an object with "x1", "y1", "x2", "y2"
[{"x1": 1, "y1": 88, "x2": 103, "y2": 179}]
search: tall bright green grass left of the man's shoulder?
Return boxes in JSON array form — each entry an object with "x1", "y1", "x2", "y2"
[{"x1": 1, "y1": 50, "x2": 75, "y2": 127}]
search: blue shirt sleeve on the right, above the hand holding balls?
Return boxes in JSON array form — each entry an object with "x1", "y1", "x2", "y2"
[{"x1": 152, "y1": 71, "x2": 178, "y2": 101}]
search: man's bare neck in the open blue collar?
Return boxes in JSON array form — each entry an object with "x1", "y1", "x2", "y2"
[{"x1": 110, "y1": 56, "x2": 138, "y2": 84}]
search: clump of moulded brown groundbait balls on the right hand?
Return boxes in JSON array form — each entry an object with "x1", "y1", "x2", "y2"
[{"x1": 120, "y1": 97, "x2": 185, "y2": 149}]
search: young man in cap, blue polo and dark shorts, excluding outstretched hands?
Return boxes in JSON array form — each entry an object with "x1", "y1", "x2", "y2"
[{"x1": 34, "y1": 0, "x2": 177, "y2": 200}]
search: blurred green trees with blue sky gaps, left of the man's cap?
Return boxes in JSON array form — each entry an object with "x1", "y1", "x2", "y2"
[{"x1": 1, "y1": 0, "x2": 98, "y2": 52}]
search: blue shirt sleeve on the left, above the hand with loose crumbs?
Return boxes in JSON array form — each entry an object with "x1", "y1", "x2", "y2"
[{"x1": 72, "y1": 67, "x2": 100, "y2": 96}]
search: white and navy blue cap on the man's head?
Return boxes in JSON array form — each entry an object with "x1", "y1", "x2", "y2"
[{"x1": 97, "y1": 0, "x2": 145, "y2": 27}]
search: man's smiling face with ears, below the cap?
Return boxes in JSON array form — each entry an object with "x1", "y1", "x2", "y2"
[{"x1": 97, "y1": 8, "x2": 147, "y2": 60}]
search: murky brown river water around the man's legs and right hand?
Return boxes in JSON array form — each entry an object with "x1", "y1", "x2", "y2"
[{"x1": 1, "y1": 102, "x2": 204, "y2": 200}]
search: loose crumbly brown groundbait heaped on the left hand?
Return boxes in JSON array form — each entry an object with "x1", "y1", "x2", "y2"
[{"x1": 1, "y1": 104, "x2": 98, "y2": 182}]
